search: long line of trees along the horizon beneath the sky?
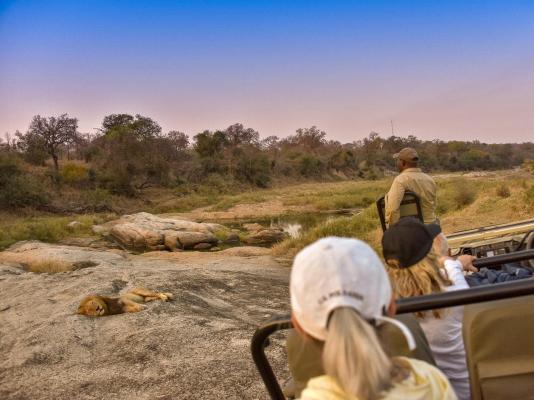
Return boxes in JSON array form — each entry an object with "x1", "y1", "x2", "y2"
[{"x1": 0, "y1": 114, "x2": 534, "y2": 208}]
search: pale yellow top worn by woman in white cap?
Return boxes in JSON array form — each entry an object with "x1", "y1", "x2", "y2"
[{"x1": 300, "y1": 357, "x2": 456, "y2": 400}]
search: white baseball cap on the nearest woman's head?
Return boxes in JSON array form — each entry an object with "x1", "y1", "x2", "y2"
[{"x1": 290, "y1": 237, "x2": 415, "y2": 350}]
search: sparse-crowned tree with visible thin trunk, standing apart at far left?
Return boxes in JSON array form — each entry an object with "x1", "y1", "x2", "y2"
[{"x1": 27, "y1": 114, "x2": 78, "y2": 182}]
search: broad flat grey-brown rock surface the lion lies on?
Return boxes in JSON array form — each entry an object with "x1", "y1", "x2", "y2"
[{"x1": 0, "y1": 248, "x2": 289, "y2": 400}]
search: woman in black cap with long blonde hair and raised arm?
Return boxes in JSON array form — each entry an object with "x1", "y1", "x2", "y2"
[{"x1": 382, "y1": 218, "x2": 476, "y2": 400}]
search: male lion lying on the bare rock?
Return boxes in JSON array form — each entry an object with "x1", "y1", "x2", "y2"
[{"x1": 76, "y1": 288, "x2": 173, "y2": 317}]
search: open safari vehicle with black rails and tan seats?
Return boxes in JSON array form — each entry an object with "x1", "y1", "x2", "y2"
[{"x1": 251, "y1": 193, "x2": 534, "y2": 400}]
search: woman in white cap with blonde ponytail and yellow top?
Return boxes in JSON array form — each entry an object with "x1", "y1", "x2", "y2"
[{"x1": 290, "y1": 237, "x2": 456, "y2": 400}]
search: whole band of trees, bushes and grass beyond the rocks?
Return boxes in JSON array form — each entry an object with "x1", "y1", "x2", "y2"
[{"x1": 0, "y1": 114, "x2": 534, "y2": 252}]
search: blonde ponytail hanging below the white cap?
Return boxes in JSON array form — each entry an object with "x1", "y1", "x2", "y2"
[{"x1": 323, "y1": 307, "x2": 394, "y2": 400}]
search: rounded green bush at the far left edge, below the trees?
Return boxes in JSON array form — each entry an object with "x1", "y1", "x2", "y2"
[{"x1": 0, "y1": 152, "x2": 46, "y2": 209}]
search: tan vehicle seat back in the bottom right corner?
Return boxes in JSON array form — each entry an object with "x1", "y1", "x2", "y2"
[{"x1": 463, "y1": 296, "x2": 534, "y2": 400}]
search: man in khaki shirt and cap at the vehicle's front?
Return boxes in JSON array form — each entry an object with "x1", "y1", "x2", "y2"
[{"x1": 385, "y1": 147, "x2": 437, "y2": 226}]
